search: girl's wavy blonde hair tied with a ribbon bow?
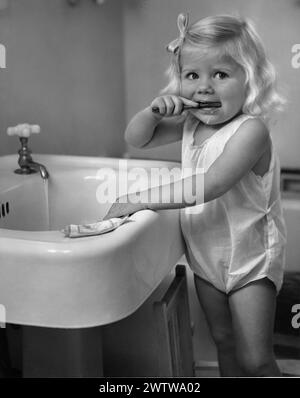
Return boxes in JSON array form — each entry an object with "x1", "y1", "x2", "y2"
[{"x1": 161, "y1": 14, "x2": 285, "y2": 119}]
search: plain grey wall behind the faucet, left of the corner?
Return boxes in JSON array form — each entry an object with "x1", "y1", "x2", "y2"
[{"x1": 0, "y1": 0, "x2": 125, "y2": 156}]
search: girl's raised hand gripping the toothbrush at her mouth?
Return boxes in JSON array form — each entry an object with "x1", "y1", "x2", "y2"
[{"x1": 150, "y1": 95, "x2": 199, "y2": 117}]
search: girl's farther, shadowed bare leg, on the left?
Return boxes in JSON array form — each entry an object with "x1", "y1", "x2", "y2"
[{"x1": 195, "y1": 275, "x2": 242, "y2": 376}]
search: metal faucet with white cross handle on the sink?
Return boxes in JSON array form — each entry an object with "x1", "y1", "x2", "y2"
[{"x1": 7, "y1": 123, "x2": 49, "y2": 180}]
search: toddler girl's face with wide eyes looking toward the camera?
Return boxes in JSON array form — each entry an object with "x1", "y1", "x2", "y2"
[{"x1": 181, "y1": 51, "x2": 246, "y2": 125}]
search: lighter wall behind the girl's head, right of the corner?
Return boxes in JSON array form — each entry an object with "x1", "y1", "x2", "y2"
[{"x1": 124, "y1": 0, "x2": 300, "y2": 168}]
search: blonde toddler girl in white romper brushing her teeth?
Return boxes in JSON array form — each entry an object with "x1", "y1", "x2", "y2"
[{"x1": 106, "y1": 14, "x2": 286, "y2": 376}]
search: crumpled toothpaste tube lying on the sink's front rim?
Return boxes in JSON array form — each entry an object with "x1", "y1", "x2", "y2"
[{"x1": 62, "y1": 216, "x2": 130, "y2": 238}]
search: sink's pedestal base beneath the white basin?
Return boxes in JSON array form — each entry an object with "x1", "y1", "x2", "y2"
[{"x1": 22, "y1": 326, "x2": 103, "y2": 378}]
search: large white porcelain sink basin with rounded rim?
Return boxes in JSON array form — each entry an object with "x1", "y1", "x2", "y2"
[{"x1": 0, "y1": 154, "x2": 184, "y2": 328}]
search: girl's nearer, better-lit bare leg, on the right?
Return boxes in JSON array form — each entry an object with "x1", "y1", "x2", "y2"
[{"x1": 229, "y1": 278, "x2": 280, "y2": 377}]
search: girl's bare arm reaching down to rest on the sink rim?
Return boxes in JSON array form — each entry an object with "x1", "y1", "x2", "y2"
[{"x1": 106, "y1": 119, "x2": 270, "y2": 218}]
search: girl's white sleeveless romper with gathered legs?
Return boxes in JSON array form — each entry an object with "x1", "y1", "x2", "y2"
[{"x1": 181, "y1": 114, "x2": 286, "y2": 293}]
